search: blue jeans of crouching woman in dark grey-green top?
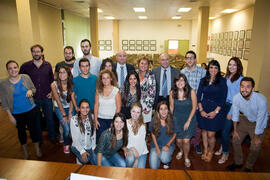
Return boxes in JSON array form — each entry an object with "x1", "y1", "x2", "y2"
[{"x1": 93, "y1": 153, "x2": 126, "y2": 167}]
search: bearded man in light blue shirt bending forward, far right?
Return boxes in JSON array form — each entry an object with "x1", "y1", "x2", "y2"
[{"x1": 228, "y1": 77, "x2": 268, "y2": 172}]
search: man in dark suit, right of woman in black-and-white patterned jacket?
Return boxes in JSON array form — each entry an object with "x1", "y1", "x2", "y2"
[{"x1": 152, "y1": 53, "x2": 180, "y2": 107}]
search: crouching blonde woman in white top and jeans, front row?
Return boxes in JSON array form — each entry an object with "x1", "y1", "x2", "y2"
[{"x1": 124, "y1": 102, "x2": 148, "y2": 168}]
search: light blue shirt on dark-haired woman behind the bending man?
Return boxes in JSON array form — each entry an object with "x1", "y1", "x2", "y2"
[{"x1": 226, "y1": 76, "x2": 243, "y2": 115}]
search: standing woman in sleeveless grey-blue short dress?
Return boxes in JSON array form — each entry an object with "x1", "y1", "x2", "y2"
[{"x1": 170, "y1": 74, "x2": 197, "y2": 167}]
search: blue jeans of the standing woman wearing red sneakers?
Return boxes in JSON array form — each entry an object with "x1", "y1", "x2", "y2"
[{"x1": 54, "y1": 106, "x2": 75, "y2": 145}]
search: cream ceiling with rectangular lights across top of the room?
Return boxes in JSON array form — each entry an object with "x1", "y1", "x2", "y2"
[{"x1": 39, "y1": 0, "x2": 255, "y2": 20}]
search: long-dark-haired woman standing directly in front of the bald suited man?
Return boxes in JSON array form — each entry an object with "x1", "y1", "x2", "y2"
[{"x1": 120, "y1": 71, "x2": 141, "y2": 119}]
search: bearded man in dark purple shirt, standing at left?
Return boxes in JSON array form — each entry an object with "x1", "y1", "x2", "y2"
[{"x1": 20, "y1": 44, "x2": 55, "y2": 143}]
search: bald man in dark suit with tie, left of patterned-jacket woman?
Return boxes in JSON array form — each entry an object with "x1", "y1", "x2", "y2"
[{"x1": 114, "y1": 51, "x2": 135, "y2": 87}]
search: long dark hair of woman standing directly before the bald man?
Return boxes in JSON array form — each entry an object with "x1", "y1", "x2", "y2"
[{"x1": 123, "y1": 70, "x2": 141, "y2": 107}]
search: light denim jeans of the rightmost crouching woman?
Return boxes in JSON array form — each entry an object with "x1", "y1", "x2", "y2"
[{"x1": 149, "y1": 146, "x2": 174, "y2": 169}]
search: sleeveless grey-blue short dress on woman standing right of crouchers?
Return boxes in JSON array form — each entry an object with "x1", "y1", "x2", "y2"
[{"x1": 173, "y1": 95, "x2": 197, "y2": 139}]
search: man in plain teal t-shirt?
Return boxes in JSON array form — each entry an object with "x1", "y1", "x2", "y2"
[{"x1": 72, "y1": 58, "x2": 97, "y2": 113}]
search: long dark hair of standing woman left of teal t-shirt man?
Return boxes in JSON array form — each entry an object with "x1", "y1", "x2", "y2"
[{"x1": 56, "y1": 65, "x2": 73, "y2": 102}]
